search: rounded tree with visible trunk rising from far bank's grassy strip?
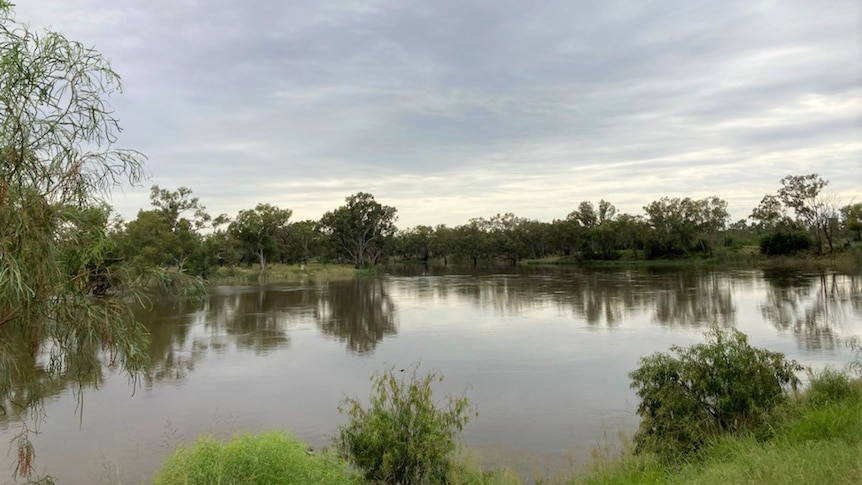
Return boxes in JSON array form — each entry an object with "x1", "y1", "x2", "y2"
[{"x1": 228, "y1": 204, "x2": 293, "y2": 273}]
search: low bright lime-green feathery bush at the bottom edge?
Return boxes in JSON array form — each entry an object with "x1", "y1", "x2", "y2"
[{"x1": 153, "y1": 432, "x2": 361, "y2": 485}]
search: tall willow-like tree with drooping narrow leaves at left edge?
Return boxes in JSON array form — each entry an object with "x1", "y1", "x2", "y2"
[{"x1": 0, "y1": 4, "x2": 153, "y2": 476}]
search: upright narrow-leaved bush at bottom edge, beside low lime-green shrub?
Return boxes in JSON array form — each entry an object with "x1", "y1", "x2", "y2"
[{"x1": 336, "y1": 365, "x2": 476, "y2": 484}]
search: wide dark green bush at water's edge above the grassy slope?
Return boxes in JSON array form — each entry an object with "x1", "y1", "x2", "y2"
[{"x1": 629, "y1": 329, "x2": 802, "y2": 460}]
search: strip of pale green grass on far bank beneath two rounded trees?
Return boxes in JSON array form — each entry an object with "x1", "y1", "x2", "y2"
[{"x1": 208, "y1": 263, "x2": 361, "y2": 284}]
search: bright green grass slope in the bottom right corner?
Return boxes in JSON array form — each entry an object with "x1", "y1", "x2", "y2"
[{"x1": 568, "y1": 371, "x2": 862, "y2": 485}]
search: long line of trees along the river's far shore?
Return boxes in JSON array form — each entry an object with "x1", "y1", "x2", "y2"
[{"x1": 108, "y1": 174, "x2": 862, "y2": 276}]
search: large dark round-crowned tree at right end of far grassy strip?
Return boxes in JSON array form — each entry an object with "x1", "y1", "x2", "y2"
[{"x1": 320, "y1": 192, "x2": 398, "y2": 268}]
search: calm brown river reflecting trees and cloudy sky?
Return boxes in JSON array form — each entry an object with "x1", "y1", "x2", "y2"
[{"x1": 0, "y1": 268, "x2": 862, "y2": 484}]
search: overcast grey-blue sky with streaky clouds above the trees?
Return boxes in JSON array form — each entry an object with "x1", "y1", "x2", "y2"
[{"x1": 8, "y1": 0, "x2": 862, "y2": 228}]
